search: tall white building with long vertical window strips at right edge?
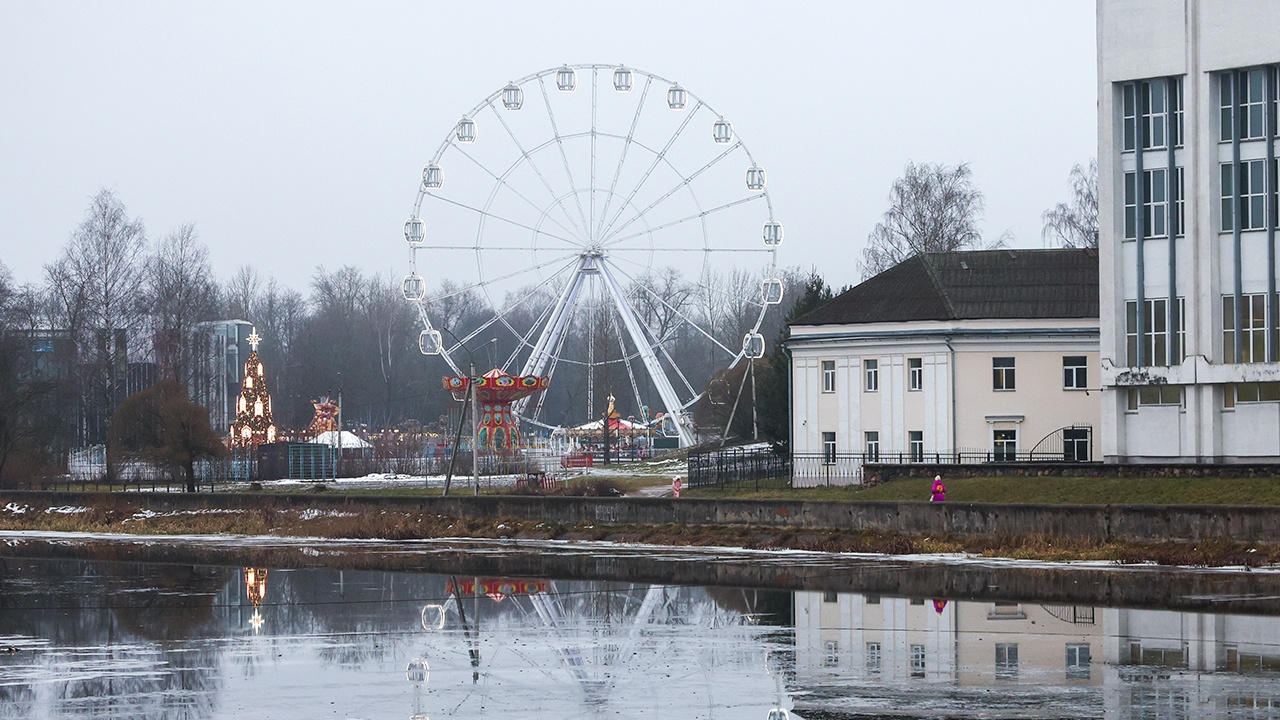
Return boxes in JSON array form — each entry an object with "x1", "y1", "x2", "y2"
[{"x1": 1097, "y1": 0, "x2": 1280, "y2": 462}]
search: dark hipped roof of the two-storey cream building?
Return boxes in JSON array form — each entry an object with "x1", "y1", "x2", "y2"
[{"x1": 791, "y1": 250, "x2": 1098, "y2": 325}]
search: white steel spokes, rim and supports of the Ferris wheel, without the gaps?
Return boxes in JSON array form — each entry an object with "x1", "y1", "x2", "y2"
[{"x1": 404, "y1": 64, "x2": 782, "y2": 447}]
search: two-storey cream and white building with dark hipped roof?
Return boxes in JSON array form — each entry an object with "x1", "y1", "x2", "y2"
[{"x1": 787, "y1": 250, "x2": 1098, "y2": 484}]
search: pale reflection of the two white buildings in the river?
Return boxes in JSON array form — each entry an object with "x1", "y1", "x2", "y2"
[{"x1": 794, "y1": 592, "x2": 1280, "y2": 720}]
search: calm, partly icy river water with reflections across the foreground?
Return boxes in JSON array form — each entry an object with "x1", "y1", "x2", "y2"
[{"x1": 0, "y1": 533, "x2": 1280, "y2": 720}]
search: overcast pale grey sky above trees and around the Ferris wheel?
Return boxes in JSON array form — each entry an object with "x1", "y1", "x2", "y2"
[{"x1": 0, "y1": 0, "x2": 1097, "y2": 291}]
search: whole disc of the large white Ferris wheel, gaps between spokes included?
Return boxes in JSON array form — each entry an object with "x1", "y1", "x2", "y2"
[{"x1": 404, "y1": 65, "x2": 782, "y2": 445}]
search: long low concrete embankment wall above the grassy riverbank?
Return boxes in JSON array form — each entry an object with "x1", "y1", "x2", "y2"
[{"x1": 0, "y1": 492, "x2": 1280, "y2": 542}]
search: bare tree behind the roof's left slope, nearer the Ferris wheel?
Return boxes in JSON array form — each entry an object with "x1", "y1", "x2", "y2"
[{"x1": 861, "y1": 163, "x2": 983, "y2": 279}]
